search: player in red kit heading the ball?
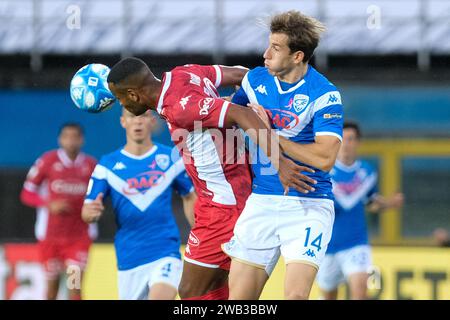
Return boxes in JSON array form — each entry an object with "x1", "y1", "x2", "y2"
[{"x1": 108, "y1": 58, "x2": 313, "y2": 300}]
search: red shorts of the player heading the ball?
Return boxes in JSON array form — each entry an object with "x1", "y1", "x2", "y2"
[{"x1": 184, "y1": 202, "x2": 242, "y2": 270}]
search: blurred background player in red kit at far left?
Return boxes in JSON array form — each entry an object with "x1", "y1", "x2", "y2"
[{"x1": 20, "y1": 123, "x2": 96, "y2": 300}]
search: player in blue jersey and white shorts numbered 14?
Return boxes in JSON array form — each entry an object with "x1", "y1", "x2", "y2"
[{"x1": 223, "y1": 11, "x2": 343, "y2": 299}]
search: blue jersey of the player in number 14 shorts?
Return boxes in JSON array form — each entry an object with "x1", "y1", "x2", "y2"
[{"x1": 233, "y1": 66, "x2": 343, "y2": 199}]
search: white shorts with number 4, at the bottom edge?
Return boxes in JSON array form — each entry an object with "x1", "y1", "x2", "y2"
[{"x1": 118, "y1": 257, "x2": 183, "y2": 300}]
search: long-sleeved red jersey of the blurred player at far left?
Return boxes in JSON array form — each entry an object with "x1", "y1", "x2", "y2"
[{"x1": 22, "y1": 149, "x2": 96, "y2": 240}]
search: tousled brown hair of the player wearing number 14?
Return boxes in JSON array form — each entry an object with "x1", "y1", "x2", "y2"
[{"x1": 270, "y1": 10, "x2": 326, "y2": 62}]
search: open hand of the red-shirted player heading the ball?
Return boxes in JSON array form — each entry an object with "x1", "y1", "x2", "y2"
[{"x1": 278, "y1": 156, "x2": 317, "y2": 195}]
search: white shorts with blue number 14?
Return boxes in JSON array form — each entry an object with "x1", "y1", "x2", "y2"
[{"x1": 222, "y1": 193, "x2": 334, "y2": 276}]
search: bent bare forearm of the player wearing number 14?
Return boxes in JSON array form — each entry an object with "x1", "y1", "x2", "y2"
[{"x1": 280, "y1": 136, "x2": 341, "y2": 171}]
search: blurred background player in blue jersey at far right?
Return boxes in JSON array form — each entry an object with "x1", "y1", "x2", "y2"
[{"x1": 317, "y1": 122, "x2": 403, "y2": 299}]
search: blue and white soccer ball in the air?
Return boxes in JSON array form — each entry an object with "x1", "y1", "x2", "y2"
[{"x1": 70, "y1": 63, "x2": 116, "y2": 113}]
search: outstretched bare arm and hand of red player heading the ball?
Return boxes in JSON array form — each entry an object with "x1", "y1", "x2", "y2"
[{"x1": 224, "y1": 104, "x2": 316, "y2": 194}]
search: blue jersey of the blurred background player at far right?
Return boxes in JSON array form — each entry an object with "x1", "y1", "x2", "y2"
[{"x1": 327, "y1": 160, "x2": 378, "y2": 253}]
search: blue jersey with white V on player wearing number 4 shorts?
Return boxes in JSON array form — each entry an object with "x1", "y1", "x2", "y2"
[{"x1": 86, "y1": 144, "x2": 193, "y2": 270}]
